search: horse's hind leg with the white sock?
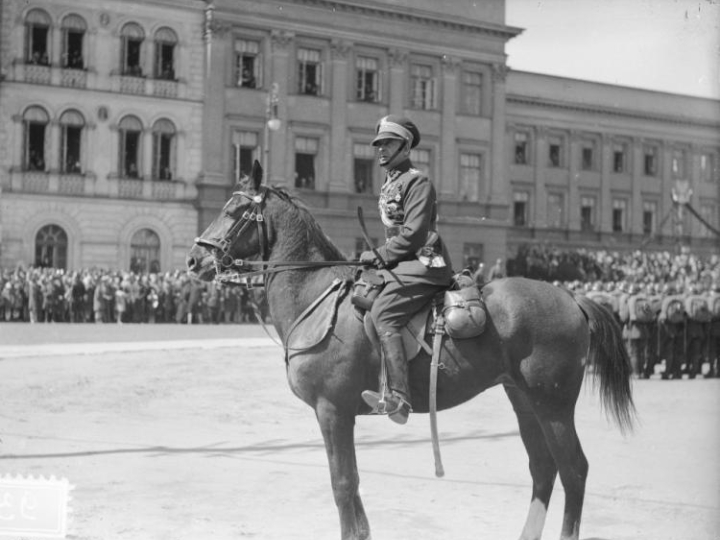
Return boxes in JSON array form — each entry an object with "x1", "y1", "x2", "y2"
[{"x1": 505, "y1": 386, "x2": 557, "y2": 540}]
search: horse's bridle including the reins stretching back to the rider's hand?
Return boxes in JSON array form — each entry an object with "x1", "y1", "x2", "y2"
[{"x1": 195, "y1": 187, "x2": 360, "y2": 284}]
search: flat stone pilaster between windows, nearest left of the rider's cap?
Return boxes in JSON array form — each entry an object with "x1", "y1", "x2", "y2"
[{"x1": 330, "y1": 40, "x2": 352, "y2": 193}]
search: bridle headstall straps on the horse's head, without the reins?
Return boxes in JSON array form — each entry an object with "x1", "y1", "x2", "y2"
[{"x1": 195, "y1": 187, "x2": 267, "y2": 276}]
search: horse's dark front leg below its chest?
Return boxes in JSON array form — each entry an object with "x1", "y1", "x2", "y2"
[{"x1": 315, "y1": 399, "x2": 370, "y2": 540}]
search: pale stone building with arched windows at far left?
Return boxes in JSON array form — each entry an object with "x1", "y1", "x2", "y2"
[{"x1": 0, "y1": 0, "x2": 205, "y2": 271}]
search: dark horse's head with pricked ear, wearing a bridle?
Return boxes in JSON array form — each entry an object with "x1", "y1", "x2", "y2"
[{"x1": 186, "y1": 161, "x2": 266, "y2": 281}]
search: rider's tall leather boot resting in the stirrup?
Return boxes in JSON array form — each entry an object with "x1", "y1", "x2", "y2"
[{"x1": 362, "y1": 333, "x2": 412, "y2": 424}]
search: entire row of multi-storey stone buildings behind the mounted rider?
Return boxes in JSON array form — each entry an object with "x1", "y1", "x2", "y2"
[{"x1": 0, "y1": 0, "x2": 720, "y2": 271}]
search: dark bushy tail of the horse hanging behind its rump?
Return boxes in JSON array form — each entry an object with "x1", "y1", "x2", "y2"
[{"x1": 575, "y1": 295, "x2": 635, "y2": 434}]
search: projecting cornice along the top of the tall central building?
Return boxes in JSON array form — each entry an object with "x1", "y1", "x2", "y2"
[{"x1": 283, "y1": 0, "x2": 523, "y2": 40}]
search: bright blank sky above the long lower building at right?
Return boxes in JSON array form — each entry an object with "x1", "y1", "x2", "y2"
[{"x1": 506, "y1": 0, "x2": 720, "y2": 99}]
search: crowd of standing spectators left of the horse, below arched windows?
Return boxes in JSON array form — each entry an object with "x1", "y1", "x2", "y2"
[{"x1": 0, "y1": 268, "x2": 266, "y2": 324}]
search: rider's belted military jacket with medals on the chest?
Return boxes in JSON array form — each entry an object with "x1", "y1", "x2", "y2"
[{"x1": 377, "y1": 160, "x2": 452, "y2": 285}]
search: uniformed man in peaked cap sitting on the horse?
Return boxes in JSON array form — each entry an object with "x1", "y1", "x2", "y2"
[{"x1": 360, "y1": 115, "x2": 452, "y2": 424}]
